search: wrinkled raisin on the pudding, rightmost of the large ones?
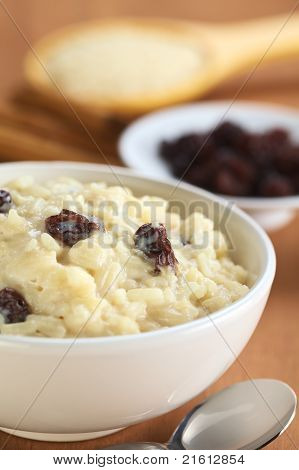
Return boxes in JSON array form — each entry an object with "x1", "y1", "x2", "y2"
[{"x1": 134, "y1": 224, "x2": 178, "y2": 273}]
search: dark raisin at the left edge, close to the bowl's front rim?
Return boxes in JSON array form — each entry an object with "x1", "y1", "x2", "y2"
[{"x1": 0, "y1": 287, "x2": 31, "y2": 323}]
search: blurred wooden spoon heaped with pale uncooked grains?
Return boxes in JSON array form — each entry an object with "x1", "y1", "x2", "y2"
[{"x1": 25, "y1": 14, "x2": 299, "y2": 118}]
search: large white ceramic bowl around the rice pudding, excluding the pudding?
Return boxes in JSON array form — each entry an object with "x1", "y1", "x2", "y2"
[{"x1": 0, "y1": 163, "x2": 275, "y2": 441}]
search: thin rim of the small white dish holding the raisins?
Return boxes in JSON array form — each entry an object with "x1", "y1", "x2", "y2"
[{"x1": 117, "y1": 99, "x2": 299, "y2": 210}]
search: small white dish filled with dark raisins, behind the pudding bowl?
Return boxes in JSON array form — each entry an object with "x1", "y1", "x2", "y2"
[{"x1": 119, "y1": 101, "x2": 299, "y2": 231}]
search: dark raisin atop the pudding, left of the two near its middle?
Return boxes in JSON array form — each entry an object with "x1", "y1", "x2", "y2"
[{"x1": 45, "y1": 209, "x2": 104, "y2": 246}]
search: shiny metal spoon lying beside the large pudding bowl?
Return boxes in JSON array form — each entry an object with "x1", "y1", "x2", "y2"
[{"x1": 109, "y1": 379, "x2": 297, "y2": 450}]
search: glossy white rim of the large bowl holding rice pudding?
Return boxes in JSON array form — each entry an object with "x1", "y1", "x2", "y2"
[{"x1": 0, "y1": 161, "x2": 276, "y2": 346}]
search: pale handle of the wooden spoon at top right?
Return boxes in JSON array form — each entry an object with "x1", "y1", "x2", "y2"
[{"x1": 205, "y1": 13, "x2": 299, "y2": 76}]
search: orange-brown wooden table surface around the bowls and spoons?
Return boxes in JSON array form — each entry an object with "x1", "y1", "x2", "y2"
[{"x1": 0, "y1": 0, "x2": 299, "y2": 449}]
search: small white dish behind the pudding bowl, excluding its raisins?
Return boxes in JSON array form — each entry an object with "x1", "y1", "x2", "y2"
[{"x1": 118, "y1": 101, "x2": 299, "y2": 231}]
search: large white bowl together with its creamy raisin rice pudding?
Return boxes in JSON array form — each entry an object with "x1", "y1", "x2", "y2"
[{"x1": 0, "y1": 162, "x2": 275, "y2": 440}]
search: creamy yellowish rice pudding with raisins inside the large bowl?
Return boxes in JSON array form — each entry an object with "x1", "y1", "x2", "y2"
[{"x1": 0, "y1": 176, "x2": 249, "y2": 338}]
